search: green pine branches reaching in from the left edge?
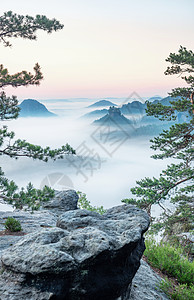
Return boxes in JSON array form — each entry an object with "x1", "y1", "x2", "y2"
[{"x1": 0, "y1": 11, "x2": 75, "y2": 210}]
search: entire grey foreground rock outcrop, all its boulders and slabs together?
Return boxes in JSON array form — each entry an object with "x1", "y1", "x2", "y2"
[{"x1": 0, "y1": 190, "x2": 168, "y2": 300}]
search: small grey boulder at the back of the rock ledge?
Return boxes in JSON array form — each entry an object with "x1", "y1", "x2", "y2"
[{"x1": 43, "y1": 190, "x2": 79, "y2": 215}]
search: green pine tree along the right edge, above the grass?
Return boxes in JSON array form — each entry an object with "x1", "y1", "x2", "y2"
[{"x1": 123, "y1": 46, "x2": 194, "y2": 250}]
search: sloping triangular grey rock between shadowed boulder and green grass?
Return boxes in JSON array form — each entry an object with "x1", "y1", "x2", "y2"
[{"x1": 128, "y1": 260, "x2": 169, "y2": 300}]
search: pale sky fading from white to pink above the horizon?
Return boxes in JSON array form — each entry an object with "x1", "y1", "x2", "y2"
[{"x1": 0, "y1": 0, "x2": 194, "y2": 100}]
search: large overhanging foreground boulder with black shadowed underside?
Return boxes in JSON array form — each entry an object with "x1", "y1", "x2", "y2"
[{"x1": 0, "y1": 205, "x2": 149, "y2": 300}]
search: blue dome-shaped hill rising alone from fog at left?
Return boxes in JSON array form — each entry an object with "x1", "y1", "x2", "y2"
[{"x1": 19, "y1": 99, "x2": 56, "y2": 117}]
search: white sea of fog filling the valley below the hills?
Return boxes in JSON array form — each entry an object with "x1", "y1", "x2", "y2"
[{"x1": 0, "y1": 99, "x2": 173, "y2": 214}]
